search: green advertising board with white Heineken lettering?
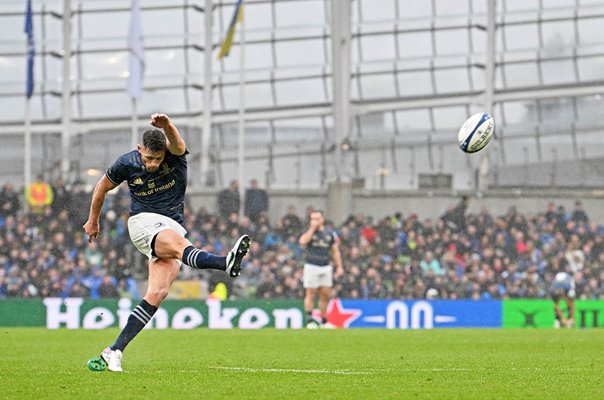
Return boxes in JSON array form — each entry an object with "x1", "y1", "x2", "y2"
[{"x1": 0, "y1": 298, "x2": 304, "y2": 329}]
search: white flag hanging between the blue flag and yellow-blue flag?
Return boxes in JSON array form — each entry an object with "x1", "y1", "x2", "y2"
[{"x1": 128, "y1": 0, "x2": 145, "y2": 99}]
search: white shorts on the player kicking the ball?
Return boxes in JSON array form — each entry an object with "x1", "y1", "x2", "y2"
[{"x1": 128, "y1": 213, "x2": 187, "y2": 265}]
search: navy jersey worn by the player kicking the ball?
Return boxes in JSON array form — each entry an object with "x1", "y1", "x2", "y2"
[{"x1": 105, "y1": 150, "x2": 189, "y2": 224}]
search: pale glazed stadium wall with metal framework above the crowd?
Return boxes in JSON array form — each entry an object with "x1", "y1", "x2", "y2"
[{"x1": 0, "y1": 0, "x2": 604, "y2": 190}]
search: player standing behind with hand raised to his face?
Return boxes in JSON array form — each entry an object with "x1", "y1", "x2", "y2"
[{"x1": 299, "y1": 211, "x2": 344, "y2": 328}]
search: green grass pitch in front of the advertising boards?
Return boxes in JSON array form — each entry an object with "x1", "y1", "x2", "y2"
[{"x1": 0, "y1": 328, "x2": 604, "y2": 400}]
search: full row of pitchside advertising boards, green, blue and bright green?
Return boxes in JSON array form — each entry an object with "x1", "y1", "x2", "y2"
[{"x1": 0, "y1": 298, "x2": 604, "y2": 329}]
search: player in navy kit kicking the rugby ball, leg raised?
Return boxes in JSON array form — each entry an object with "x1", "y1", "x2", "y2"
[{"x1": 84, "y1": 114, "x2": 250, "y2": 371}]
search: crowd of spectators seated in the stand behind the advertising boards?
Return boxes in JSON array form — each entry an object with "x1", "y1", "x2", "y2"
[{"x1": 0, "y1": 181, "x2": 604, "y2": 300}]
